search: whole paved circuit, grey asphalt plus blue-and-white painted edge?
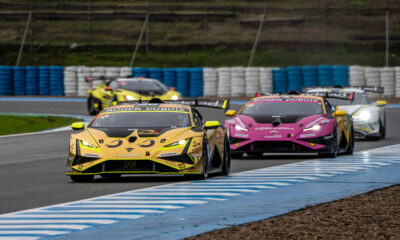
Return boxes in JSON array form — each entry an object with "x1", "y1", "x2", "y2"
[{"x1": 0, "y1": 101, "x2": 400, "y2": 239}]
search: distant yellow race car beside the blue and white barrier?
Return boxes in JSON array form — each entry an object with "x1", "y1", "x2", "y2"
[{"x1": 86, "y1": 77, "x2": 182, "y2": 115}]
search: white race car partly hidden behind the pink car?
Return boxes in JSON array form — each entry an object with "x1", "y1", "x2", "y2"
[{"x1": 303, "y1": 86, "x2": 386, "y2": 140}]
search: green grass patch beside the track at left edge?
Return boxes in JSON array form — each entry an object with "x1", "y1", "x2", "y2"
[{"x1": 0, "y1": 115, "x2": 80, "y2": 135}]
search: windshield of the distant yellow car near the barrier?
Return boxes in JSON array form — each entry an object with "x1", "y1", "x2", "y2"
[{"x1": 110, "y1": 79, "x2": 168, "y2": 96}]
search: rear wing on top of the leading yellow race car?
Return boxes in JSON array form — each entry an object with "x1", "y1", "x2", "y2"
[{"x1": 116, "y1": 98, "x2": 230, "y2": 111}]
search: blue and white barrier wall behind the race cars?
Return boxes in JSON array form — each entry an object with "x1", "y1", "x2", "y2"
[{"x1": 0, "y1": 65, "x2": 400, "y2": 97}]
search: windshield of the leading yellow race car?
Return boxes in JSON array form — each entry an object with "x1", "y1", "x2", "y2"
[{"x1": 89, "y1": 111, "x2": 191, "y2": 129}]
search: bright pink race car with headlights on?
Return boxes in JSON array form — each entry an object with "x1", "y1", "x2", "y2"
[{"x1": 225, "y1": 95, "x2": 354, "y2": 158}]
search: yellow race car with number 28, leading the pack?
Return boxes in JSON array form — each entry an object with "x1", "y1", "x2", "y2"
[{"x1": 66, "y1": 99, "x2": 231, "y2": 181}]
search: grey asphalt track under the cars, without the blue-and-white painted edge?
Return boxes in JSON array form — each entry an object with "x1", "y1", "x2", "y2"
[{"x1": 0, "y1": 102, "x2": 400, "y2": 214}]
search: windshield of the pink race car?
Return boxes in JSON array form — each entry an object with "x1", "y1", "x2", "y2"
[{"x1": 240, "y1": 98, "x2": 323, "y2": 115}]
